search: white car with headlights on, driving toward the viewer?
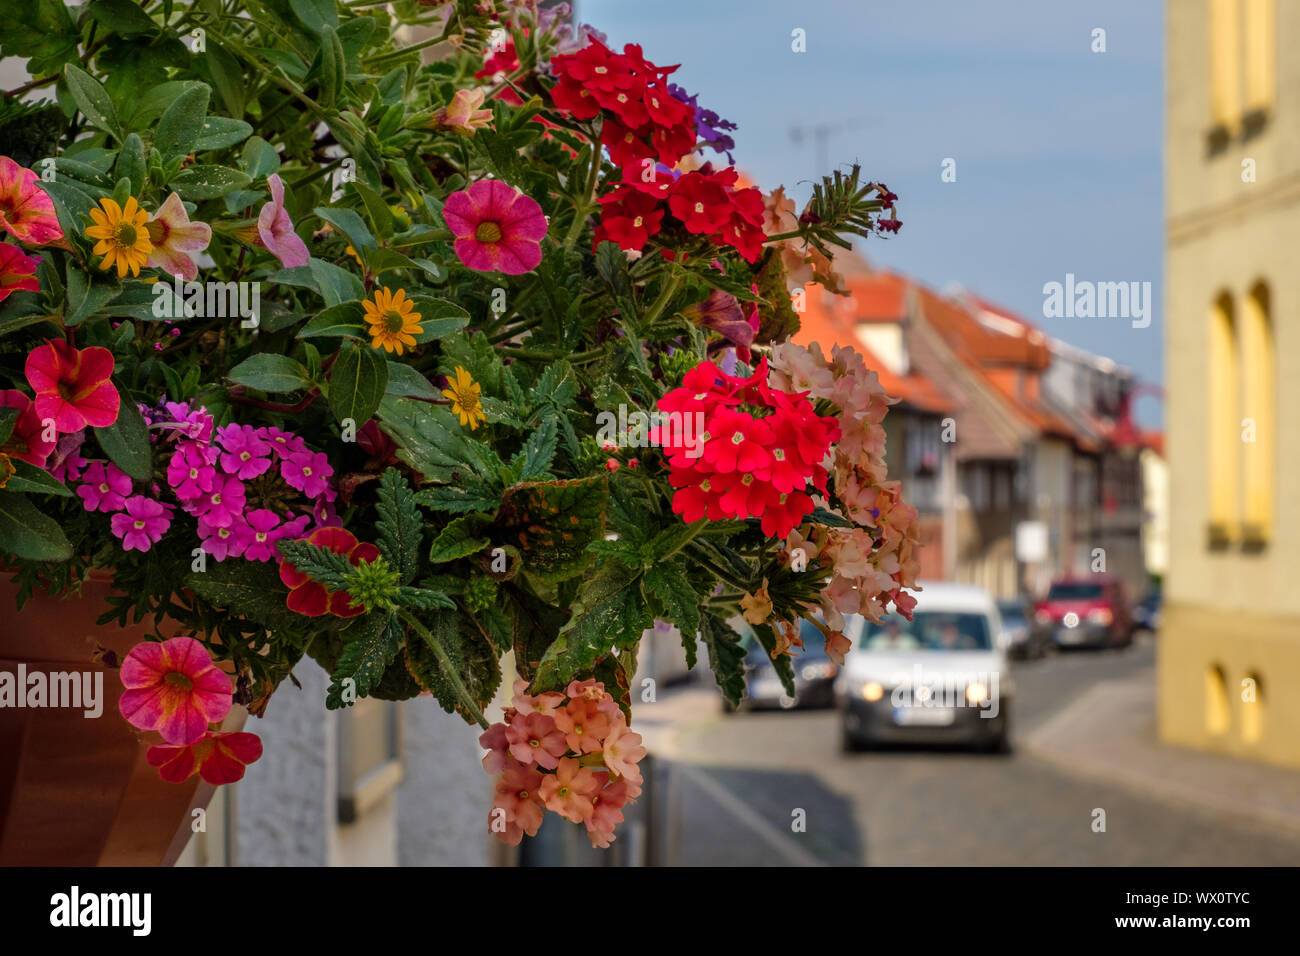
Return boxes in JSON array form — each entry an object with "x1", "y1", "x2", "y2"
[{"x1": 836, "y1": 581, "x2": 1013, "y2": 750}]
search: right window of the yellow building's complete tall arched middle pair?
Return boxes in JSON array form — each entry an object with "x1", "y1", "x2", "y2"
[{"x1": 1239, "y1": 282, "x2": 1277, "y2": 545}]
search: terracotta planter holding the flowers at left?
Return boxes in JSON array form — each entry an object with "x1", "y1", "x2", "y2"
[{"x1": 0, "y1": 575, "x2": 246, "y2": 866}]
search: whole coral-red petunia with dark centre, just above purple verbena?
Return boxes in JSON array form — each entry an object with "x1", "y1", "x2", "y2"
[{"x1": 23, "y1": 338, "x2": 121, "y2": 434}]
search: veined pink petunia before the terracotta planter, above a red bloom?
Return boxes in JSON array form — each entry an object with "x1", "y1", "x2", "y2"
[{"x1": 117, "y1": 637, "x2": 231, "y2": 744}]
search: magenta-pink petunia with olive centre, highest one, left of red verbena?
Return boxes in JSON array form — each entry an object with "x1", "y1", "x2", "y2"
[{"x1": 442, "y1": 179, "x2": 546, "y2": 276}]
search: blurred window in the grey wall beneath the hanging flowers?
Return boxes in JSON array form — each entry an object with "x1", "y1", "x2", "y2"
[{"x1": 338, "y1": 697, "x2": 402, "y2": 823}]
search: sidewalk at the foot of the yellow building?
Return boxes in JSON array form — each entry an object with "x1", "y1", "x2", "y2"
[{"x1": 1017, "y1": 671, "x2": 1300, "y2": 832}]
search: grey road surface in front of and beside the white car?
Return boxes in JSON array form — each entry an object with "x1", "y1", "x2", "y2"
[{"x1": 672, "y1": 641, "x2": 1300, "y2": 866}]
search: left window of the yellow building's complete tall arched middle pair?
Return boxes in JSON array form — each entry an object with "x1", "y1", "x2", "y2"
[{"x1": 1205, "y1": 293, "x2": 1242, "y2": 538}]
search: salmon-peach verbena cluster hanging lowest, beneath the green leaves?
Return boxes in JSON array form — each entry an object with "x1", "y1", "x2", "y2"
[{"x1": 478, "y1": 679, "x2": 646, "y2": 847}]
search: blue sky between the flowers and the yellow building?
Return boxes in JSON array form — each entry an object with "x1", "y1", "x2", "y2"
[{"x1": 576, "y1": 0, "x2": 1165, "y2": 425}]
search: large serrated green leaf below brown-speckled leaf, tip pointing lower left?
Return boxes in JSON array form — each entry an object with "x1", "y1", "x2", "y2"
[{"x1": 537, "y1": 566, "x2": 654, "y2": 689}]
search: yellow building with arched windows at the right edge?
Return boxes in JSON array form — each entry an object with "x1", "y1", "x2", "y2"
[{"x1": 1157, "y1": 0, "x2": 1300, "y2": 766}]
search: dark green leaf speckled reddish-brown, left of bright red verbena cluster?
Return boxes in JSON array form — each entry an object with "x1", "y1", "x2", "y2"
[{"x1": 494, "y1": 475, "x2": 610, "y2": 581}]
